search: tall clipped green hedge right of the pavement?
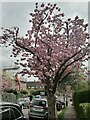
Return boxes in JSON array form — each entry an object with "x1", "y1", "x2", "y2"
[{"x1": 73, "y1": 90, "x2": 90, "y2": 120}]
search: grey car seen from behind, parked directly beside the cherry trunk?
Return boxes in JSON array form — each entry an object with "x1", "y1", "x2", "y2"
[{"x1": 28, "y1": 99, "x2": 48, "y2": 119}]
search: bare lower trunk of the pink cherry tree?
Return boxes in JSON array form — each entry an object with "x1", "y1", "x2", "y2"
[{"x1": 47, "y1": 93, "x2": 56, "y2": 120}]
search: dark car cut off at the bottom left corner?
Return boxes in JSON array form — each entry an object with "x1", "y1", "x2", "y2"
[{"x1": 0, "y1": 102, "x2": 26, "y2": 120}]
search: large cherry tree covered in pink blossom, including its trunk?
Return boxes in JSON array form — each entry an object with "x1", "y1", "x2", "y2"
[{"x1": 0, "y1": 3, "x2": 89, "y2": 118}]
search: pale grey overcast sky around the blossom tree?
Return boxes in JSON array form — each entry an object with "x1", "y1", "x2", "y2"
[{"x1": 0, "y1": 0, "x2": 90, "y2": 80}]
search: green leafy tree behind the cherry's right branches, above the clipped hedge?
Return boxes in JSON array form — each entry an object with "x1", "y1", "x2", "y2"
[{"x1": 57, "y1": 68, "x2": 88, "y2": 98}]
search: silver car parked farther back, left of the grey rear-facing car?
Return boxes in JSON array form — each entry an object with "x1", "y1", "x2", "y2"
[{"x1": 16, "y1": 97, "x2": 30, "y2": 109}]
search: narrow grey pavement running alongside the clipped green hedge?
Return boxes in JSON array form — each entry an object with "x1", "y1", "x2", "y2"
[{"x1": 64, "y1": 105, "x2": 79, "y2": 120}]
